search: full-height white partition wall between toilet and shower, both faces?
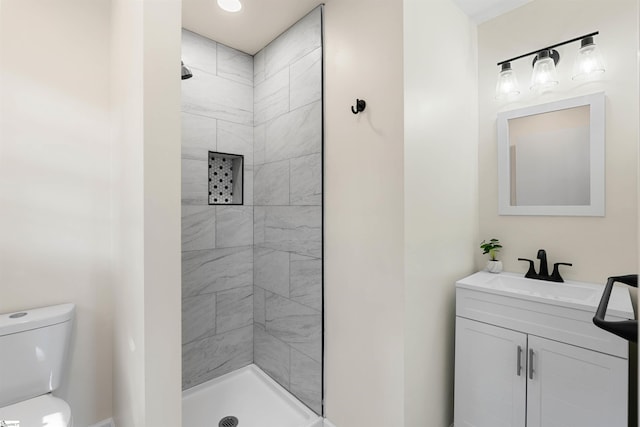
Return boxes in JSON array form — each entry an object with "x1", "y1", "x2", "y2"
[{"x1": 111, "y1": 0, "x2": 181, "y2": 427}]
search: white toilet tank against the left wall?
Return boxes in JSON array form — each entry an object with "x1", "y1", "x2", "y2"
[{"x1": 0, "y1": 304, "x2": 75, "y2": 407}]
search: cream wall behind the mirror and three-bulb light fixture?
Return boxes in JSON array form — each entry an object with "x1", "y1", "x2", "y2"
[{"x1": 476, "y1": 0, "x2": 638, "y2": 283}]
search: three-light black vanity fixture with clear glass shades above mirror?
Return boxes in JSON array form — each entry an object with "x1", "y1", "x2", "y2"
[{"x1": 496, "y1": 31, "x2": 604, "y2": 99}]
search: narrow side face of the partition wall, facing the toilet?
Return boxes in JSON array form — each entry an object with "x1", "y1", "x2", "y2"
[{"x1": 111, "y1": 0, "x2": 145, "y2": 427}]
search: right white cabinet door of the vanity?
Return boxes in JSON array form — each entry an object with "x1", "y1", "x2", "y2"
[{"x1": 527, "y1": 335, "x2": 628, "y2": 427}]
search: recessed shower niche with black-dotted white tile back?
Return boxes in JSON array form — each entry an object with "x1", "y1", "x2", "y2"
[{"x1": 209, "y1": 151, "x2": 244, "y2": 205}]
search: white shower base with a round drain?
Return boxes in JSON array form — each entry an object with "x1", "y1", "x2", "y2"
[{"x1": 182, "y1": 365, "x2": 323, "y2": 427}]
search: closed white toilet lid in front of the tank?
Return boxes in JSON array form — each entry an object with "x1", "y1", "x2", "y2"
[{"x1": 0, "y1": 394, "x2": 71, "y2": 427}]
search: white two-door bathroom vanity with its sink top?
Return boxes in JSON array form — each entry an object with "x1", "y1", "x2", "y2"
[{"x1": 454, "y1": 272, "x2": 634, "y2": 427}]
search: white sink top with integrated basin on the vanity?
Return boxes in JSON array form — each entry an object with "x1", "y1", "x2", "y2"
[{"x1": 456, "y1": 271, "x2": 633, "y2": 319}]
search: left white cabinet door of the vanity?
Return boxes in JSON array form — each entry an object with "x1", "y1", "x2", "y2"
[{"x1": 454, "y1": 317, "x2": 524, "y2": 427}]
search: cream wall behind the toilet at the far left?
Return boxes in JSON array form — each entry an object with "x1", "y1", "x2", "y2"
[{"x1": 0, "y1": 0, "x2": 113, "y2": 427}]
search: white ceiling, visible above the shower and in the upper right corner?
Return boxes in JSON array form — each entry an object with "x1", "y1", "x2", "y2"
[{"x1": 182, "y1": 0, "x2": 533, "y2": 55}]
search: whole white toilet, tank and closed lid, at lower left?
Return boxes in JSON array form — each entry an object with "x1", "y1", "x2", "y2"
[{"x1": 0, "y1": 304, "x2": 75, "y2": 427}]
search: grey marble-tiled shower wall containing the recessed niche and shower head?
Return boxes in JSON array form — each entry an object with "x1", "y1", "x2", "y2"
[{"x1": 182, "y1": 30, "x2": 254, "y2": 389}]
